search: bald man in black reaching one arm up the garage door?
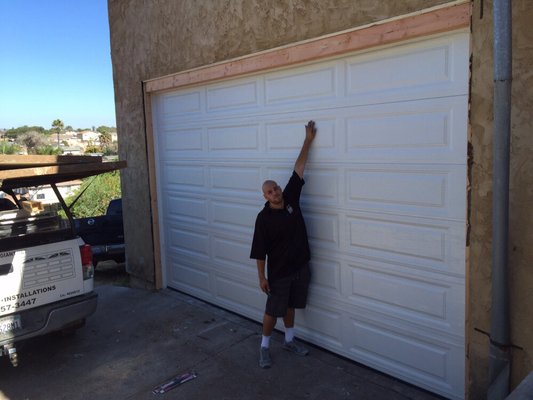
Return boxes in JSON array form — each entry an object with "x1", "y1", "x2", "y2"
[{"x1": 250, "y1": 121, "x2": 316, "y2": 368}]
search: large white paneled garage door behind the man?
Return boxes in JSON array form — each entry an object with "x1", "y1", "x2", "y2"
[{"x1": 152, "y1": 32, "x2": 469, "y2": 398}]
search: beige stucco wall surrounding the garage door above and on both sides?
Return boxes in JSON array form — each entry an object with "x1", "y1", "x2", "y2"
[{"x1": 109, "y1": 0, "x2": 533, "y2": 399}]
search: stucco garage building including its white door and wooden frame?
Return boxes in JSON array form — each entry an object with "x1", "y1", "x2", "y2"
[{"x1": 109, "y1": 0, "x2": 533, "y2": 399}]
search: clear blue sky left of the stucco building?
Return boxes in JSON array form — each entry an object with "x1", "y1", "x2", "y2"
[{"x1": 0, "y1": 0, "x2": 116, "y2": 129}]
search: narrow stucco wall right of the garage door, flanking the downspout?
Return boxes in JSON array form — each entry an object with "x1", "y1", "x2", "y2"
[{"x1": 467, "y1": 0, "x2": 533, "y2": 398}]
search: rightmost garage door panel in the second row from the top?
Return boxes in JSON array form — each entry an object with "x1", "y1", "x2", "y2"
[{"x1": 346, "y1": 96, "x2": 468, "y2": 164}]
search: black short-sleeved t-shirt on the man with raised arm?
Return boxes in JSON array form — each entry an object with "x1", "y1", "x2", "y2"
[{"x1": 250, "y1": 172, "x2": 310, "y2": 282}]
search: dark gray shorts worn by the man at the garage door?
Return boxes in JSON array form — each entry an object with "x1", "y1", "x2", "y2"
[{"x1": 265, "y1": 265, "x2": 311, "y2": 318}]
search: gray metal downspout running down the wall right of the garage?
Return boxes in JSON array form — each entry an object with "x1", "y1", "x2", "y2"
[{"x1": 487, "y1": 0, "x2": 512, "y2": 400}]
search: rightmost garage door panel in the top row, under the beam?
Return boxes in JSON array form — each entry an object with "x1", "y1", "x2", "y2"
[{"x1": 346, "y1": 35, "x2": 469, "y2": 103}]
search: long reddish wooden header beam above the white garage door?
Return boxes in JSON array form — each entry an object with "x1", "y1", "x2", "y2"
[{"x1": 145, "y1": 2, "x2": 472, "y2": 93}]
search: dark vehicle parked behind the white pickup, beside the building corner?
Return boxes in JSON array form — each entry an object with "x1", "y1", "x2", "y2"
[{"x1": 74, "y1": 199, "x2": 125, "y2": 267}]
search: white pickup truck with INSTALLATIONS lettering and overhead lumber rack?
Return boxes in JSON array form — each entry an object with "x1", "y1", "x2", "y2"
[{"x1": 0, "y1": 156, "x2": 125, "y2": 366}]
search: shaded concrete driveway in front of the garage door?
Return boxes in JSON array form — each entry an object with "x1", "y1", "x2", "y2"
[{"x1": 0, "y1": 285, "x2": 441, "y2": 400}]
